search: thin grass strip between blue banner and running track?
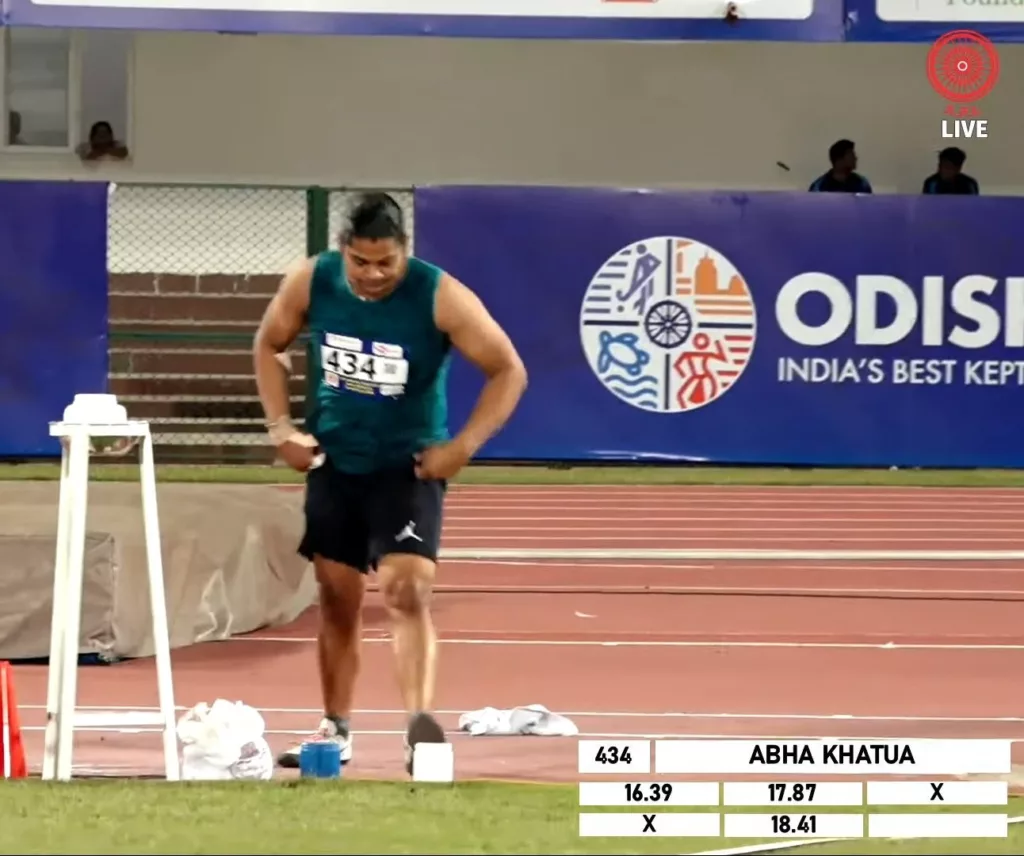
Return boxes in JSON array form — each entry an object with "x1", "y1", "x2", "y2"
[{"x1": 6, "y1": 459, "x2": 1024, "y2": 487}]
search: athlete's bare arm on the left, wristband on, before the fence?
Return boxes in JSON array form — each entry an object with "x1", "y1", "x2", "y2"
[{"x1": 253, "y1": 259, "x2": 315, "y2": 469}]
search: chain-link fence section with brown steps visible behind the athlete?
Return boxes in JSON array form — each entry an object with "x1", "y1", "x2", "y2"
[{"x1": 108, "y1": 184, "x2": 413, "y2": 463}]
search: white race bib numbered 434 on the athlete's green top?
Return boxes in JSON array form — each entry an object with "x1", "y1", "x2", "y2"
[{"x1": 321, "y1": 334, "x2": 409, "y2": 397}]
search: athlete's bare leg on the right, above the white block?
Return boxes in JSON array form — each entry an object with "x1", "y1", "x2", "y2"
[{"x1": 377, "y1": 553, "x2": 436, "y2": 716}]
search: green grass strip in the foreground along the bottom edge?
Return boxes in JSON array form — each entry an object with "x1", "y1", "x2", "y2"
[{"x1": 0, "y1": 780, "x2": 1024, "y2": 856}]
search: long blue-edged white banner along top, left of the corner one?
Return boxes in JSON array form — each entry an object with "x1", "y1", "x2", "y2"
[{"x1": 4, "y1": 0, "x2": 844, "y2": 42}]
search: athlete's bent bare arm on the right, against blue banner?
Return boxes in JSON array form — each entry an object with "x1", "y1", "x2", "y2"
[{"x1": 434, "y1": 274, "x2": 526, "y2": 458}]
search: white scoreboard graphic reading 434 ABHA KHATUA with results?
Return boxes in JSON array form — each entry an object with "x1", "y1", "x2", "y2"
[{"x1": 579, "y1": 738, "x2": 1012, "y2": 839}]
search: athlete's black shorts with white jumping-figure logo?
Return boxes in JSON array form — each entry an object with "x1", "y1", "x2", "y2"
[{"x1": 299, "y1": 461, "x2": 447, "y2": 572}]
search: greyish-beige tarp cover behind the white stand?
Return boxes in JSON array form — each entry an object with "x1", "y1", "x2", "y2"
[{"x1": 0, "y1": 481, "x2": 316, "y2": 659}]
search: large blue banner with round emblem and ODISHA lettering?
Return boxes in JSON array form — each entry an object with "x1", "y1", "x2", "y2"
[{"x1": 416, "y1": 187, "x2": 1024, "y2": 467}]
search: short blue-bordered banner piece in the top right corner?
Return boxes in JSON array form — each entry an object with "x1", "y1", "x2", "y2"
[{"x1": 845, "y1": 0, "x2": 1024, "y2": 42}]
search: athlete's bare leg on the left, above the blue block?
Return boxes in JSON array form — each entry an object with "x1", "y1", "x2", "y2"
[{"x1": 313, "y1": 556, "x2": 366, "y2": 720}]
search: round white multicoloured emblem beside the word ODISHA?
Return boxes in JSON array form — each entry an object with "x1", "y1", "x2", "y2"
[{"x1": 580, "y1": 237, "x2": 757, "y2": 413}]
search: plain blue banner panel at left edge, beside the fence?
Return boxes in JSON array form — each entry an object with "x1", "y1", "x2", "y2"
[{"x1": 0, "y1": 181, "x2": 108, "y2": 458}]
